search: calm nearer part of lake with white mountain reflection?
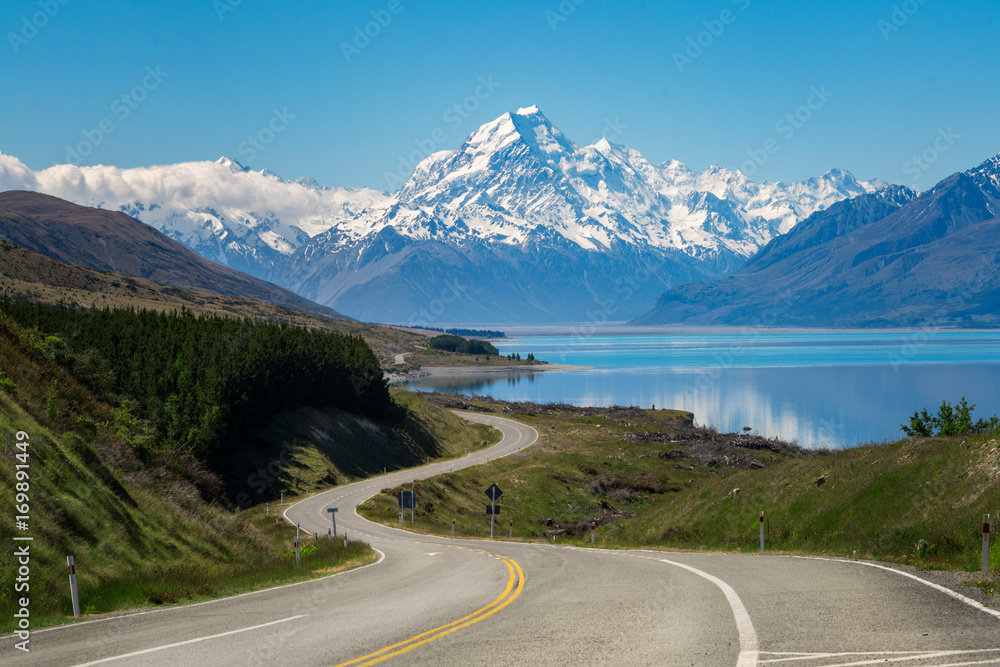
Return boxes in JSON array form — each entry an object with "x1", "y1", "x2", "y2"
[{"x1": 403, "y1": 363, "x2": 1000, "y2": 448}]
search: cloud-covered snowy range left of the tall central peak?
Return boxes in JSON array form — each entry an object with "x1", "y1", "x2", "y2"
[{"x1": 0, "y1": 154, "x2": 389, "y2": 276}]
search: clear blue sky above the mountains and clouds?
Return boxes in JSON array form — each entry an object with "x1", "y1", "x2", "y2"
[{"x1": 0, "y1": 0, "x2": 1000, "y2": 190}]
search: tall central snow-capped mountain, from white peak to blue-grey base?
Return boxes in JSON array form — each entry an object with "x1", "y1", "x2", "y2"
[{"x1": 273, "y1": 107, "x2": 882, "y2": 324}]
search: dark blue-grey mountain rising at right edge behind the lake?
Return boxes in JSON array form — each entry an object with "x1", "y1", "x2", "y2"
[{"x1": 634, "y1": 155, "x2": 1000, "y2": 327}]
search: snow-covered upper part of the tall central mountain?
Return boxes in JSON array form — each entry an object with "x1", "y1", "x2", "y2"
[{"x1": 339, "y1": 106, "x2": 882, "y2": 258}]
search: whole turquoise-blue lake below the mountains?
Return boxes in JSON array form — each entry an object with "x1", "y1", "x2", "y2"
[{"x1": 401, "y1": 329, "x2": 1000, "y2": 448}]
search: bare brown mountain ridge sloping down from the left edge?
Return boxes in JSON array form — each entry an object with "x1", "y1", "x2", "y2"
[{"x1": 0, "y1": 190, "x2": 350, "y2": 320}]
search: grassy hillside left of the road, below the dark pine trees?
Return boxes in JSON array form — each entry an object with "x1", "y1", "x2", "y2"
[{"x1": 0, "y1": 320, "x2": 490, "y2": 631}]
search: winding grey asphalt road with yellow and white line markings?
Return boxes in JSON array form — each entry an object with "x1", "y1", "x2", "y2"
[{"x1": 19, "y1": 415, "x2": 1000, "y2": 667}]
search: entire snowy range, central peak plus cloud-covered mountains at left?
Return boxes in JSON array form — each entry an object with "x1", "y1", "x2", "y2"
[{"x1": 0, "y1": 107, "x2": 885, "y2": 325}]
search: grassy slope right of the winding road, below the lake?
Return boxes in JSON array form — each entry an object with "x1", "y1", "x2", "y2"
[{"x1": 365, "y1": 402, "x2": 1000, "y2": 570}]
